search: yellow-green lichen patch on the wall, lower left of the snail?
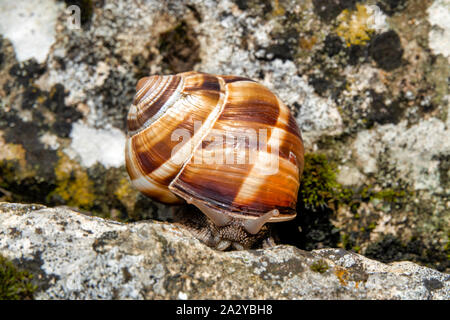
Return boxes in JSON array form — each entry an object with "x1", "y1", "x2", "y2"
[{"x1": 51, "y1": 151, "x2": 95, "y2": 208}]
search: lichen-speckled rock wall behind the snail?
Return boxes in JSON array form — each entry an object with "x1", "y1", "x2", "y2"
[{"x1": 0, "y1": 0, "x2": 450, "y2": 272}]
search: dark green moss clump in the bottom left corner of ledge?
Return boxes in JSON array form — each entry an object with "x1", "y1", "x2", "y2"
[{"x1": 0, "y1": 256, "x2": 37, "y2": 300}]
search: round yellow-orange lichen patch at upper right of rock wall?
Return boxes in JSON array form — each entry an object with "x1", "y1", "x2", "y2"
[{"x1": 336, "y1": 3, "x2": 374, "y2": 46}]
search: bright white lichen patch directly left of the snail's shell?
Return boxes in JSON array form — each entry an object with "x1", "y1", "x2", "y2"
[{"x1": 64, "y1": 122, "x2": 125, "y2": 168}]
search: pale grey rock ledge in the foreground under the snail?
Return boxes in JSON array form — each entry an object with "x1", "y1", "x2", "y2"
[{"x1": 0, "y1": 203, "x2": 450, "y2": 300}]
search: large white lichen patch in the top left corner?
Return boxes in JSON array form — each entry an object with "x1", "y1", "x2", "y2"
[{"x1": 0, "y1": 0, "x2": 63, "y2": 63}]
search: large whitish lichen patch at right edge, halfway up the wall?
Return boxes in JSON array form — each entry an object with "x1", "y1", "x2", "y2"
[{"x1": 353, "y1": 113, "x2": 450, "y2": 192}]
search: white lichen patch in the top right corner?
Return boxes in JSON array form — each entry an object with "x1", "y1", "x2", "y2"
[{"x1": 427, "y1": 0, "x2": 450, "y2": 58}]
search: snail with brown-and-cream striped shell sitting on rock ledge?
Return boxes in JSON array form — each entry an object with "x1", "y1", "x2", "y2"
[{"x1": 125, "y1": 71, "x2": 304, "y2": 250}]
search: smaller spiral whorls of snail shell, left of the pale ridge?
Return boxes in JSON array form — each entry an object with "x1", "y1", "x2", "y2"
[{"x1": 125, "y1": 73, "x2": 224, "y2": 203}]
